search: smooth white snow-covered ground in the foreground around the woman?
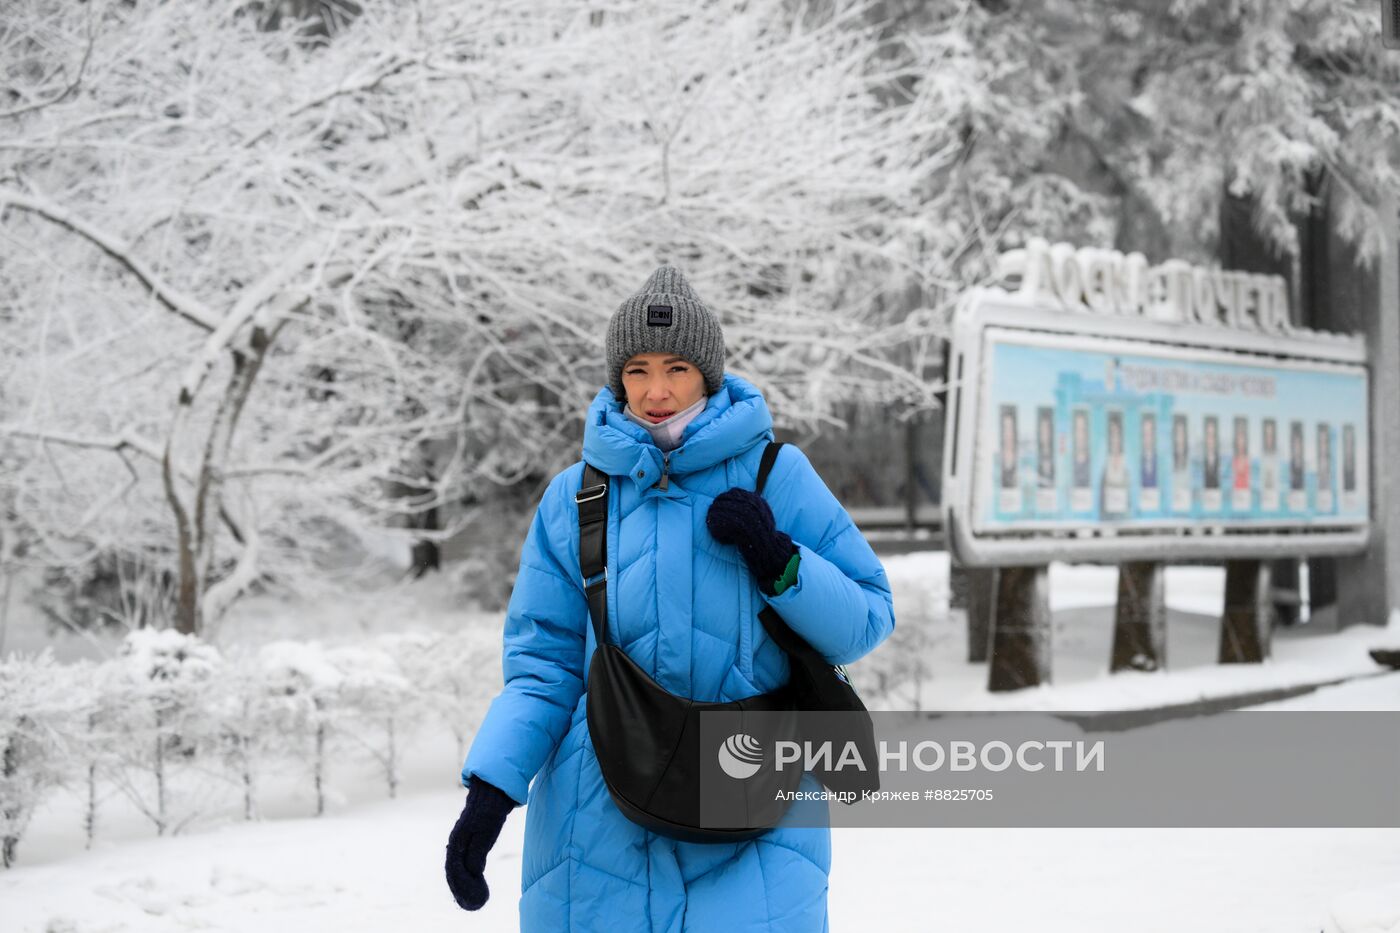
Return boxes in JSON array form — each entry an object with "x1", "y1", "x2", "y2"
[{"x1": 0, "y1": 664, "x2": 1400, "y2": 933}]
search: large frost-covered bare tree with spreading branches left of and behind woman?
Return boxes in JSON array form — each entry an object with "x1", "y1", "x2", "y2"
[{"x1": 0, "y1": 0, "x2": 952, "y2": 630}]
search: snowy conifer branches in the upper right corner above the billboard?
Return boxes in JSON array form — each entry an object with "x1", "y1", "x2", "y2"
[{"x1": 983, "y1": 0, "x2": 1400, "y2": 262}]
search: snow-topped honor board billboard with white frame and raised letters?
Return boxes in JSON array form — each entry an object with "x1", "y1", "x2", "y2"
[{"x1": 944, "y1": 241, "x2": 1371, "y2": 566}]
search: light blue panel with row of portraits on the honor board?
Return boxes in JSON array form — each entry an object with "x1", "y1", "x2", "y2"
[{"x1": 973, "y1": 328, "x2": 1369, "y2": 532}]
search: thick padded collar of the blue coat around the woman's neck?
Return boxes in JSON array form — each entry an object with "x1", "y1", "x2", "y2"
[{"x1": 584, "y1": 373, "x2": 773, "y2": 489}]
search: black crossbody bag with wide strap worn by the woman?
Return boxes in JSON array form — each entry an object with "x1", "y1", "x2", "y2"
[{"x1": 574, "y1": 443, "x2": 879, "y2": 842}]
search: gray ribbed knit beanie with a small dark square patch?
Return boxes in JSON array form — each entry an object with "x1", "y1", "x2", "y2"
[{"x1": 606, "y1": 265, "x2": 724, "y2": 401}]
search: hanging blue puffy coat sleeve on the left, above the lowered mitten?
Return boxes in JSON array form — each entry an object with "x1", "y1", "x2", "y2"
[{"x1": 462, "y1": 468, "x2": 588, "y2": 803}]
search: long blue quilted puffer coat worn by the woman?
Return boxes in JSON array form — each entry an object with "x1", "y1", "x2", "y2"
[{"x1": 462, "y1": 374, "x2": 895, "y2": 933}]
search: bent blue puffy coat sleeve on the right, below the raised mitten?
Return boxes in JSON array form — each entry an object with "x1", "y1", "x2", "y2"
[{"x1": 764, "y1": 444, "x2": 895, "y2": 664}]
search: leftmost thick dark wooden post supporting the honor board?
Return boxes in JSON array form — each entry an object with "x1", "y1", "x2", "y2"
[{"x1": 987, "y1": 565, "x2": 1050, "y2": 692}]
